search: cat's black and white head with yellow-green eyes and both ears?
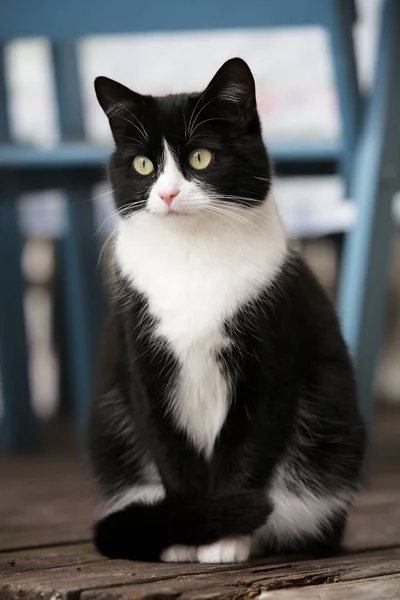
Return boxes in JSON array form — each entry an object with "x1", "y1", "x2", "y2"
[{"x1": 95, "y1": 58, "x2": 271, "y2": 218}]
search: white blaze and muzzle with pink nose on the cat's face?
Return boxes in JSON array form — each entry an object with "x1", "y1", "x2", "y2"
[{"x1": 147, "y1": 140, "x2": 211, "y2": 215}]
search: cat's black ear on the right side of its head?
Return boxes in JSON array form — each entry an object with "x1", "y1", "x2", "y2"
[{"x1": 204, "y1": 58, "x2": 257, "y2": 122}]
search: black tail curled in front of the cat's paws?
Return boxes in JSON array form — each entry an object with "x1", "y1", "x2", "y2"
[{"x1": 94, "y1": 490, "x2": 271, "y2": 561}]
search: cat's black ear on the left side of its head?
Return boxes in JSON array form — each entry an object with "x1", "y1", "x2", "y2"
[{"x1": 94, "y1": 77, "x2": 145, "y2": 141}]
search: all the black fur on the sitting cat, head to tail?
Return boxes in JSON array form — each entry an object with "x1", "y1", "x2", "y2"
[{"x1": 90, "y1": 61, "x2": 364, "y2": 560}]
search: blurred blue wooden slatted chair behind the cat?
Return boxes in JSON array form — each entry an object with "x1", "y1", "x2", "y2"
[{"x1": 0, "y1": 0, "x2": 400, "y2": 447}]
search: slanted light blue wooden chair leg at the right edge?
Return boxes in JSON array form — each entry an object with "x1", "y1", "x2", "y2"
[{"x1": 339, "y1": 0, "x2": 400, "y2": 432}]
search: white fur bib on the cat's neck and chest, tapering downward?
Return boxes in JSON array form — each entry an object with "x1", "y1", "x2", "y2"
[{"x1": 116, "y1": 200, "x2": 286, "y2": 456}]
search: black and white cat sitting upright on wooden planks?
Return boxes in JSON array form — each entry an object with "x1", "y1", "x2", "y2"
[{"x1": 90, "y1": 58, "x2": 364, "y2": 562}]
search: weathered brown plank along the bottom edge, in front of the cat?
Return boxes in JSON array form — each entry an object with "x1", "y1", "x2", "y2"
[{"x1": 0, "y1": 548, "x2": 400, "y2": 600}]
